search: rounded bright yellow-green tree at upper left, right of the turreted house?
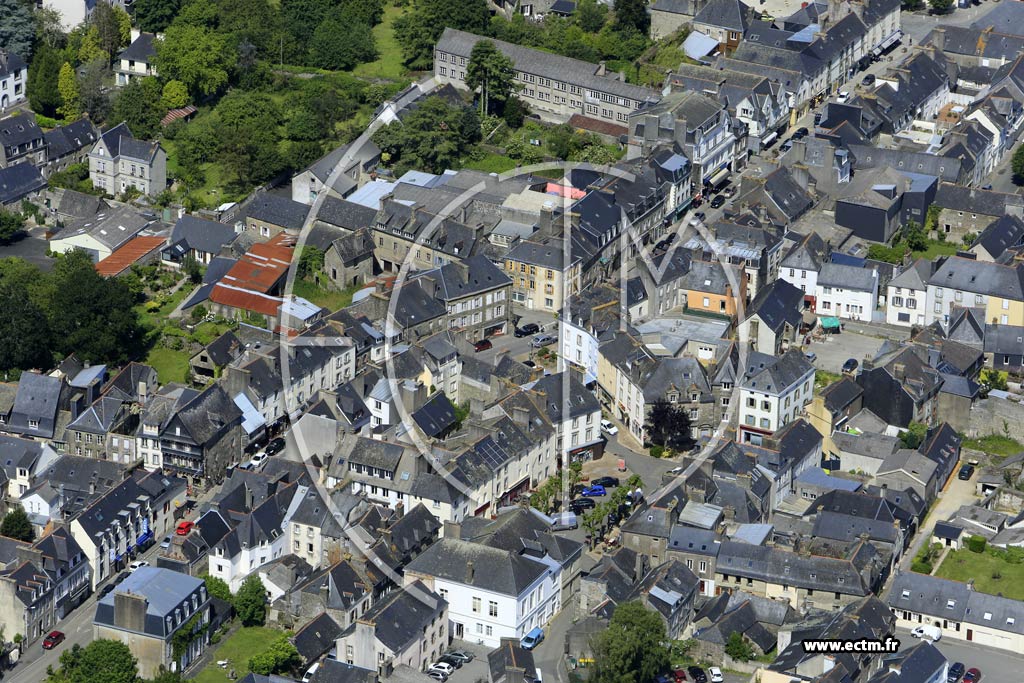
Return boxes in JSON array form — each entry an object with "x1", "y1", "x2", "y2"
[{"x1": 156, "y1": 24, "x2": 237, "y2": 97}]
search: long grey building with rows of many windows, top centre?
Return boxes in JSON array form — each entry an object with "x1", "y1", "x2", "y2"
[{"x1": 434, "y1": 29, "x2": 660, "y2": 128}]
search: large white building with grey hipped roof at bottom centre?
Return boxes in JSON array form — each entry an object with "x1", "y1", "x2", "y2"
[{"x1": 404, "y1": 530, "x2": 562, "y2": 648}]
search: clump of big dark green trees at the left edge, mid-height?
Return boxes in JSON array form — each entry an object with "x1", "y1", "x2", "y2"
[{"x1": 0, "y1": 251, "x2": 146, "y2": 373}]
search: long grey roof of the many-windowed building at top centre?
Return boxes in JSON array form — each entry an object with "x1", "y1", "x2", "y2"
[{"x1": 434, "y1": 29, "x2": 658, "y2": 103}]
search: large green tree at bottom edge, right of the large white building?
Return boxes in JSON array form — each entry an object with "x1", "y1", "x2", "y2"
[{"x1": 590, "y1": 602, "x2": 669, "y2": 683}]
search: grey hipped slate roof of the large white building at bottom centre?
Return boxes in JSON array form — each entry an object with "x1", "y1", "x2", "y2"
[{"x1": 406, "y1": 539, "x2": 548, "y2": 596}]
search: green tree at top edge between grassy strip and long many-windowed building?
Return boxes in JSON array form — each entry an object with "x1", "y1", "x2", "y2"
[{"x1": 394, "y1": 0, "x2": 490, "y2": 70}]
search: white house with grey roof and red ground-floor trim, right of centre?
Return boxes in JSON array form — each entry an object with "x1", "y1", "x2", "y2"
[{"x1": 739, "y1": 349, "x2": 814, "y2": 445}]
